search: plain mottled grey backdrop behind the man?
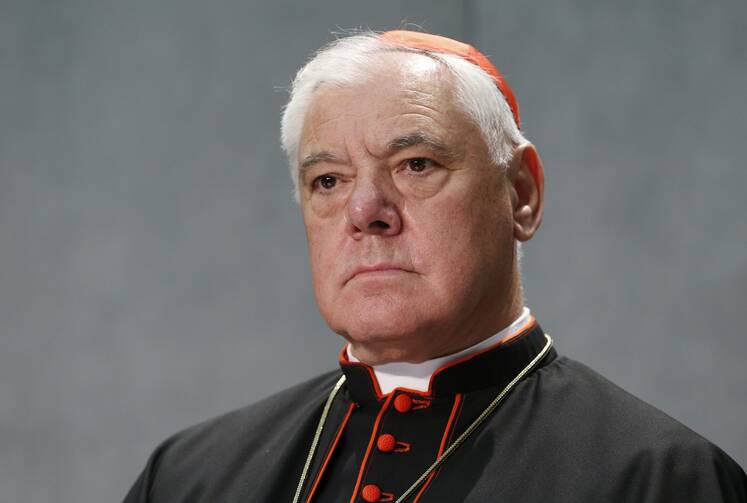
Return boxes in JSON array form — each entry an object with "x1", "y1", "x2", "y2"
[{"x1": 0, "y1": 0, "x2": 747, "y2": 503}]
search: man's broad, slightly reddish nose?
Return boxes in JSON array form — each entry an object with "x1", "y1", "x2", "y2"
[{"x1": 347, "y1": 174, "x2": 402, "y2": 239}]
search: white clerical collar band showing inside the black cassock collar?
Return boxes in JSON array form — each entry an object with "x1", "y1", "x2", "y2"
[{"x1": 346, "y1": 307, "x2": 532, "y2": 395}]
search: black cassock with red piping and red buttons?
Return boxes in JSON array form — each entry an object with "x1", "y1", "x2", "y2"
[{"x1": 125, "y1": 324, "x2": 747, "y2": 503}]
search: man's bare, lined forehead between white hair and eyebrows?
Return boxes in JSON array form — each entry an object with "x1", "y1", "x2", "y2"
[{"x1": 299, "y1": 52, "x2": 471, "y2": 156}]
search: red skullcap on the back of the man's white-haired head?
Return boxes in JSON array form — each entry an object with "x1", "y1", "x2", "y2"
[{"x1": 379, "y1": 30, "x2": 521, "y2": 128}]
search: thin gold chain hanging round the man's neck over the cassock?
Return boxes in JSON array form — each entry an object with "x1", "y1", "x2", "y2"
[{"x1": 293, "y1": 334, "x2": 552, "y2": 503}]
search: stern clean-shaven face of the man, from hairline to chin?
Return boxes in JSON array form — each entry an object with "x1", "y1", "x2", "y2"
[{"x1": 299, "y1": 53, "x2": 520, "y2": 364}]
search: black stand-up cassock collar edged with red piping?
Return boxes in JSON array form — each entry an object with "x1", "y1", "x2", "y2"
[{"x1": 340, "y1": 317, "x2": 554, "y2": 403}]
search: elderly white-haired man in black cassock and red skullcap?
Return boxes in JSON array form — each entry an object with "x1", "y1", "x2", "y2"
[{"x1": 126, "y1": 31, "x2": 747, "y2": 503}]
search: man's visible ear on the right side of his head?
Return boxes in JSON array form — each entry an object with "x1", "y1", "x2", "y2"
[{"x1": 507, "y1": 143, "x2": 545, "y2": 241}]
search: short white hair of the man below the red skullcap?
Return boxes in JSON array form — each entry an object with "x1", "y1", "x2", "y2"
[{"x1": 281, "y1": 31, "x2": 527, "y2": 201}]
